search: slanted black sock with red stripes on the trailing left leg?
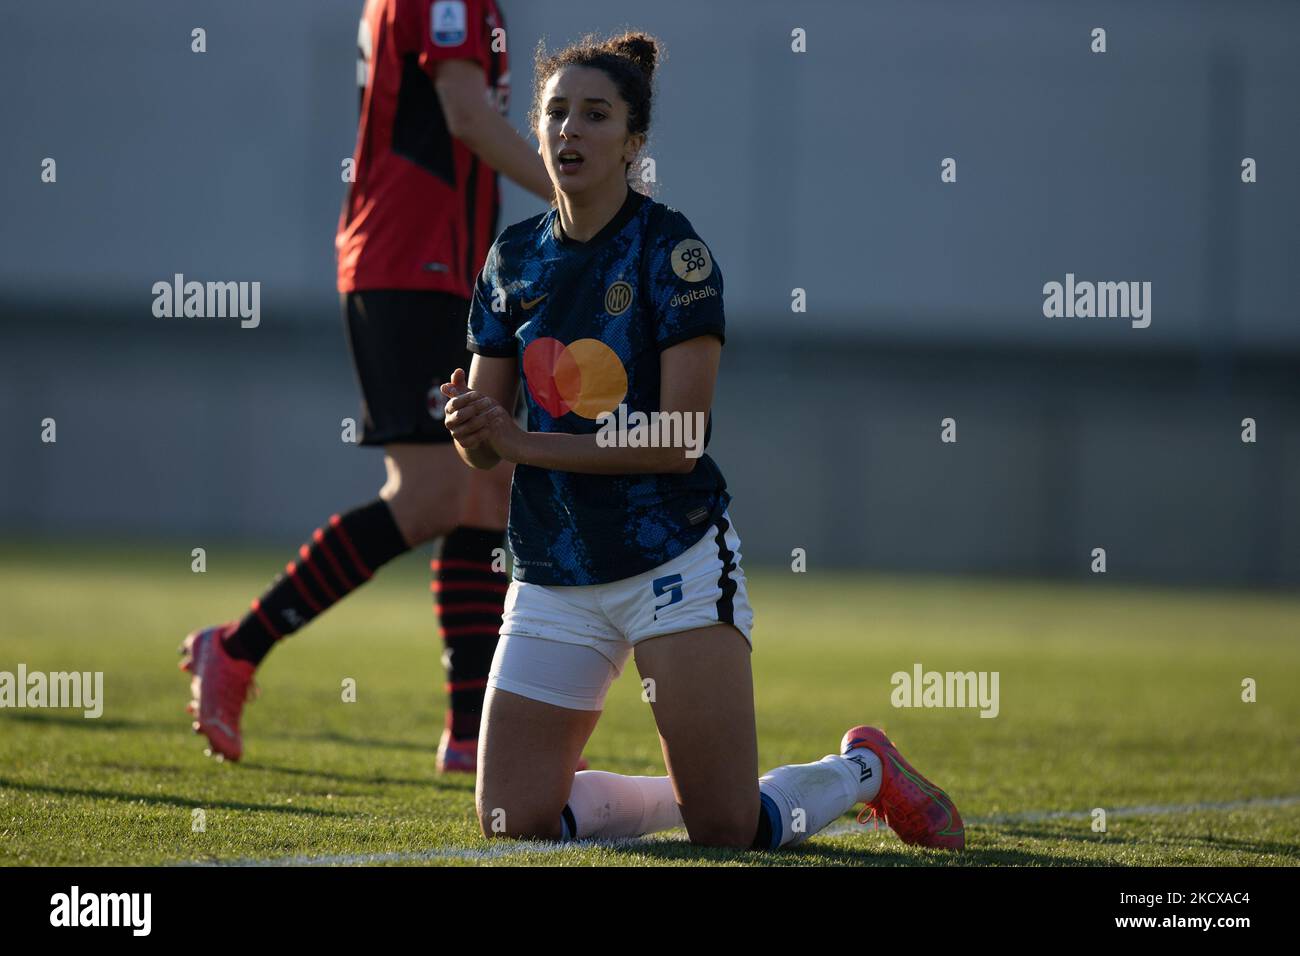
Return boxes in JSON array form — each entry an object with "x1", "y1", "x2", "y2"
[{"x1": 224, "y1": 498, "x2": 411, "y2": 663}]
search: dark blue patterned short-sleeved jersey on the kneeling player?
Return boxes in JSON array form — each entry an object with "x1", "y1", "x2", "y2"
[{"x1": 468, "y1": 189, "x2": 731, "y2": 587}]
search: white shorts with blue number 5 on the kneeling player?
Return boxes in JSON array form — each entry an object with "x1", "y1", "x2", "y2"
[{"x1": 488, "y1": 511, "x2": 754, "y2": 710}]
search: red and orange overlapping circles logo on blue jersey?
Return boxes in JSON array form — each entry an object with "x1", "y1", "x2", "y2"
[{"x1": 524, "y1": 336, "x2": 628, "y2": 421}]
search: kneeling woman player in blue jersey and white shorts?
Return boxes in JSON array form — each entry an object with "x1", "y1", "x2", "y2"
[{"x1": 443, "y1": 34, "x2": 965, "y2": 849}]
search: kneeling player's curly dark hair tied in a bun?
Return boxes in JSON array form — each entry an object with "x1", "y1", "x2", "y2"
[{"x1": 528, "y1": 30, "x2": 663, "y2": 192}]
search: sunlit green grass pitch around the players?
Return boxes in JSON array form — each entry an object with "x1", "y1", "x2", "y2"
[{"x1": 0, "y1": 542, "x2": 1300, "y2": 866}]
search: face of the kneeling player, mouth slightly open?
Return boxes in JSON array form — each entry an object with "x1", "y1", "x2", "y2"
[{"x1": 537, "y1": 66, "x2": 645, "y2": 195}]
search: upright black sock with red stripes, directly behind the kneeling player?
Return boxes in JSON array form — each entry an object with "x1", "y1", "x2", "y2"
[{"x1": 430, "y1": 528, "x2": 510, "y2": 740}]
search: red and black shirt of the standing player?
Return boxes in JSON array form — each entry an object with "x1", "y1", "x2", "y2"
[{"x1": 334, "y1": 0, "x2": 510, "y2": 299}]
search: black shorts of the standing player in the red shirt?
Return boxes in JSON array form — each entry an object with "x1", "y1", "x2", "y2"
[{"x1": 341, "y1": 289, "x2": 473, "y2": 445}]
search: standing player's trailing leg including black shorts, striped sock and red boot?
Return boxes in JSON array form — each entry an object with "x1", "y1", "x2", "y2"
[{"x1": 181, "y1": 290, "x2": 483, "y2": 760}]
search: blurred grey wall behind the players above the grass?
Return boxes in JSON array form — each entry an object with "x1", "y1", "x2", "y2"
[{"x1": 0, "y1": 0, "x2": 1300, "y2": 584}]
